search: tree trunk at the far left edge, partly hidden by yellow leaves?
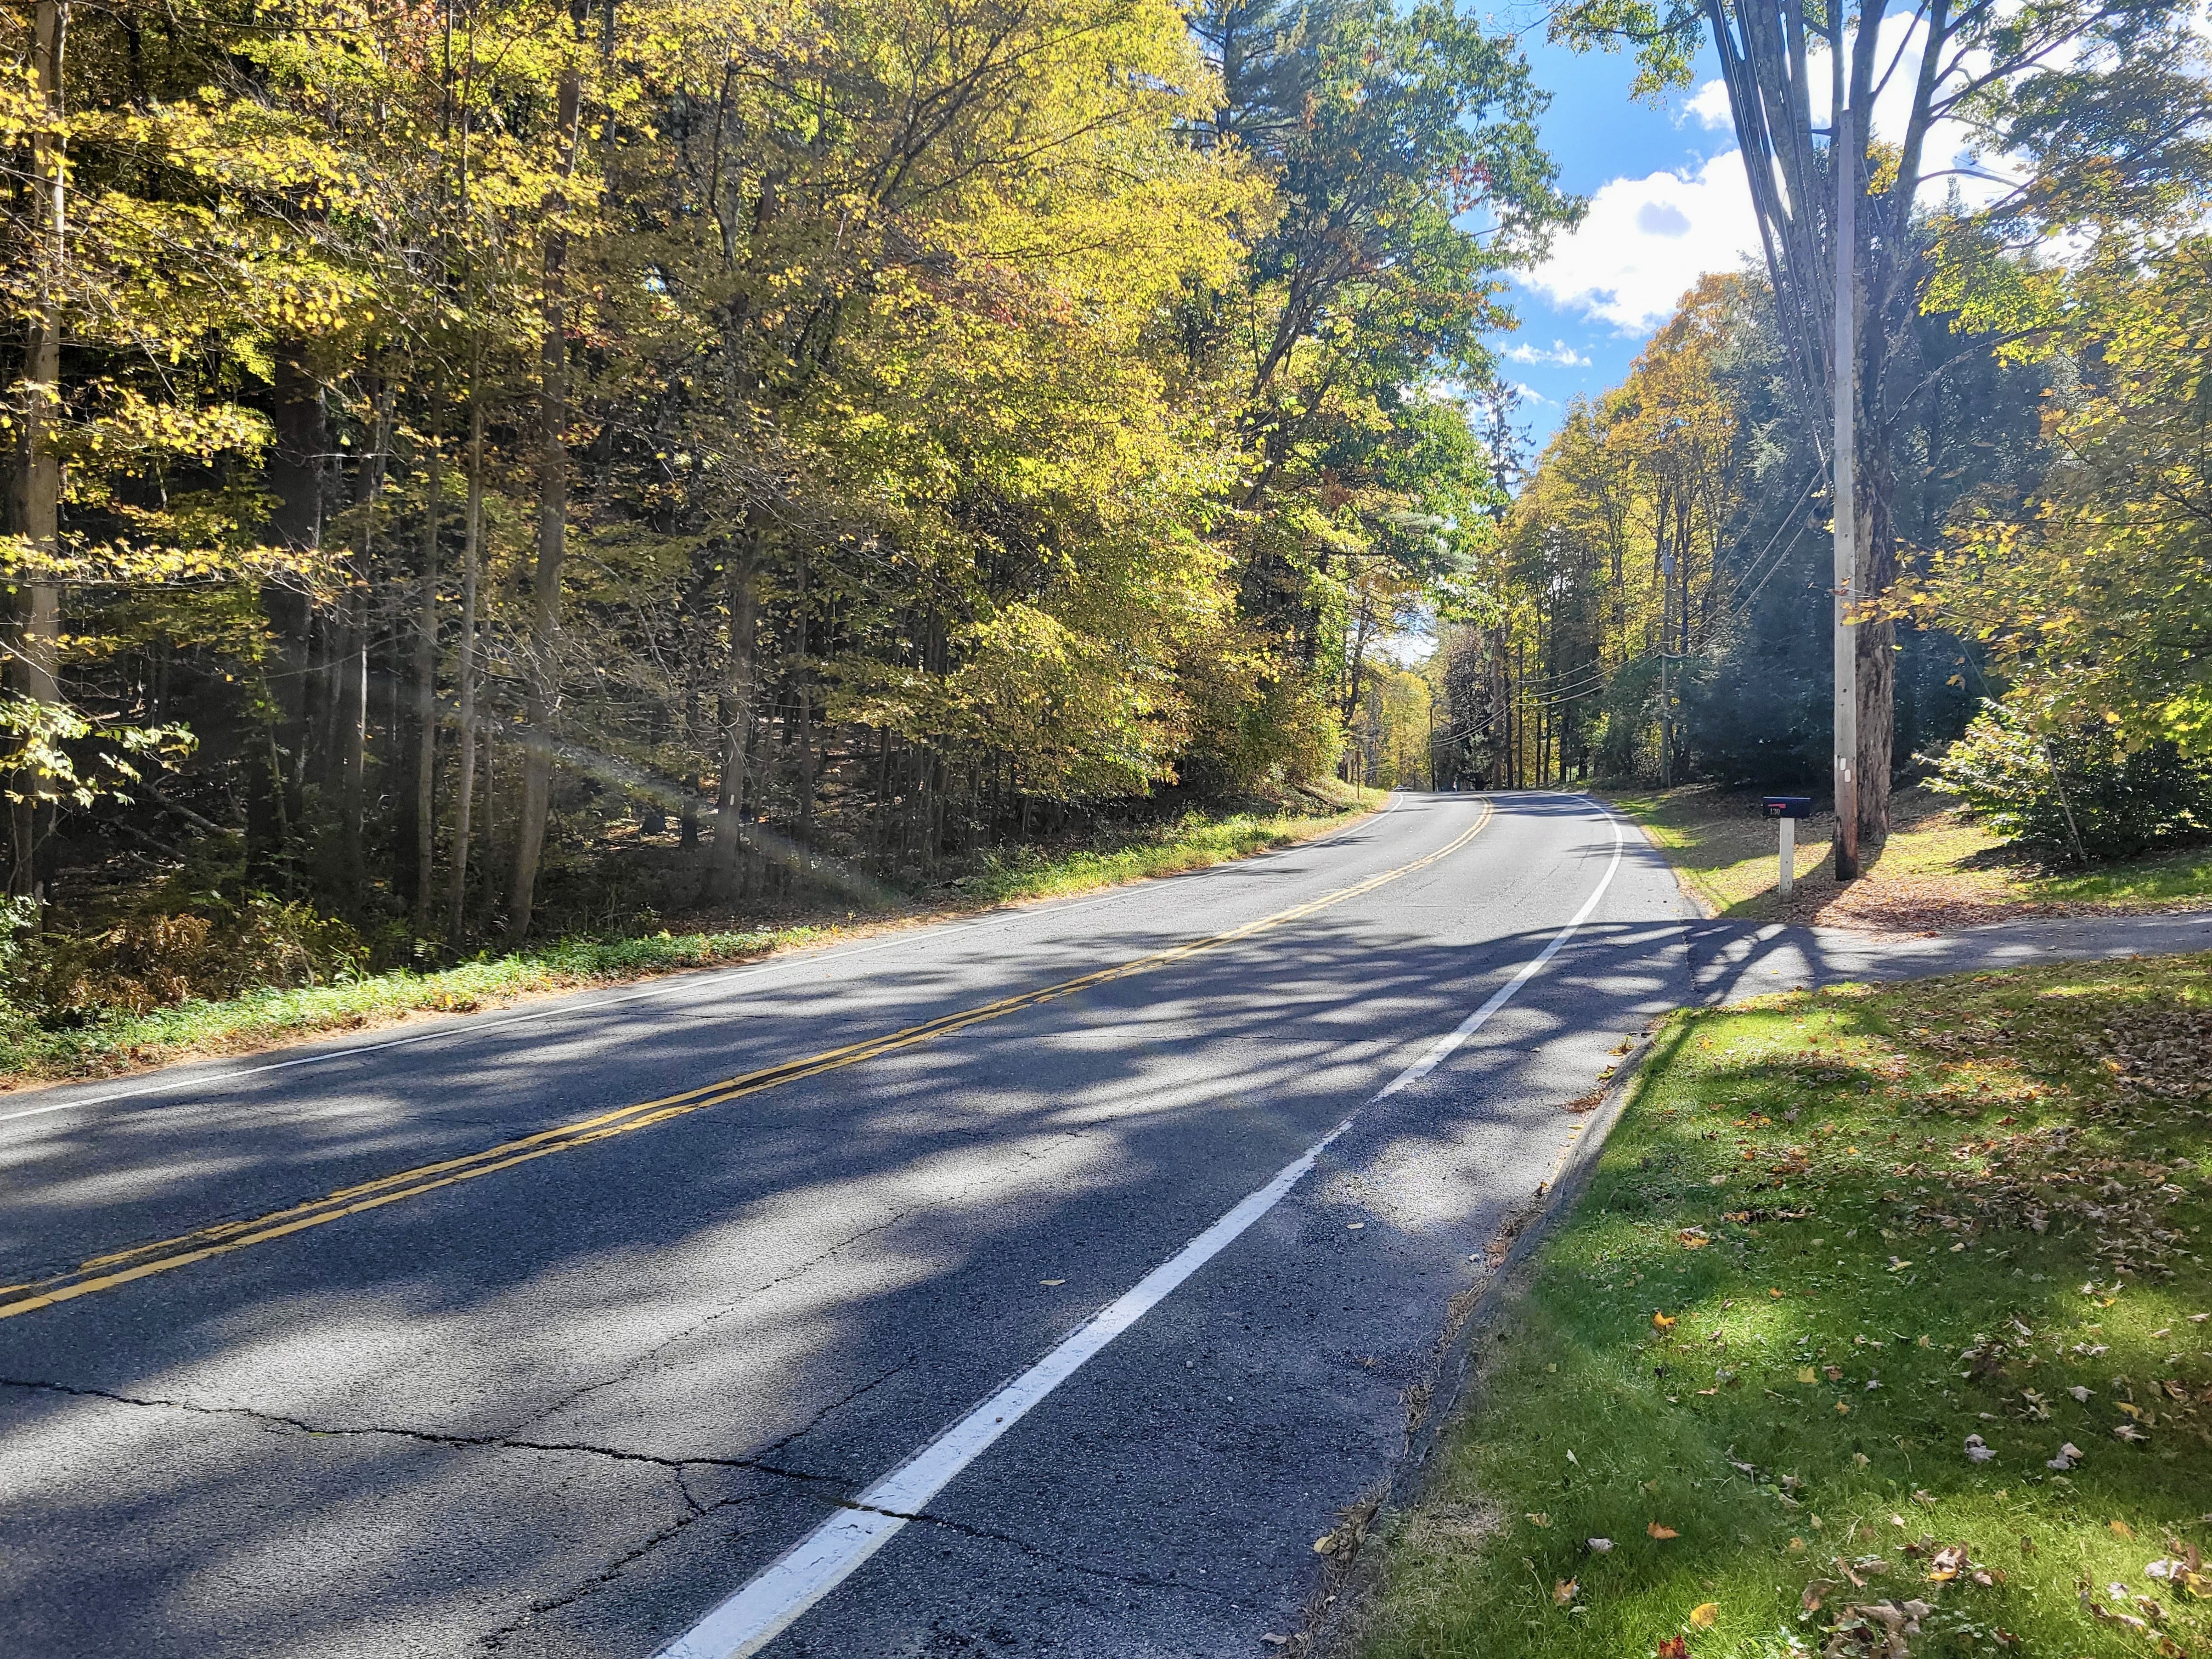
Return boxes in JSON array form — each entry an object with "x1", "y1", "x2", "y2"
[{"x1": 9, "y1": 0, "x2": 69, "y2": 898}]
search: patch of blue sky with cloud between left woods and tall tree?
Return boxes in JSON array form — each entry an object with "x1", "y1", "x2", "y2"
[{"x1": 1493, "y1": 20, "x2": 1756, "y2": 462}]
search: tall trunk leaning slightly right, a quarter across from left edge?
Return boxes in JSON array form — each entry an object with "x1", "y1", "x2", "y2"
[{"x1": 506, "y1": 64, "x2": 584, "y2": 945}]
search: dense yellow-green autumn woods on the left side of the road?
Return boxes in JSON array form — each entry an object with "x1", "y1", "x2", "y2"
[{"x1": 0, "y1": 0, "x2": 1575, "y2": 1000}]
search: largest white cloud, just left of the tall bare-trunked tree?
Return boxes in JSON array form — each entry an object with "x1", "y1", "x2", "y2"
[{"x1": 1528, "y1": 150, "x2": 1758, "y2": 330}]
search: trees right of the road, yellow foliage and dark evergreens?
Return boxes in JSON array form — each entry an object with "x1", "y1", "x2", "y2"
[{"x1": 1423, "y1": 0, "x2": 2212, "y2": 862}]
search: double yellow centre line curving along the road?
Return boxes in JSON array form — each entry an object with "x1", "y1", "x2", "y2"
[{"x1": 0, "y1": 801, "x2": 1498, "y2": 1318}]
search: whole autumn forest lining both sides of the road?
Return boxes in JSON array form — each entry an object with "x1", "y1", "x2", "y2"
[{"x1": 0, "y1": 0, "x2": 2212, "y2": 1022}]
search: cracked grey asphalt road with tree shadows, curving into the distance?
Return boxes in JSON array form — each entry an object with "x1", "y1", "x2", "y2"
[{"x1": 0, "y1": 794, "x2": 1692, "y2": 1659}]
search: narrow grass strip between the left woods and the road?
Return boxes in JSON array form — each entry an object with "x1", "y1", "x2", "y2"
[{"x1": 0, "y1": 789, "x2": 1385, "y2": 1086}]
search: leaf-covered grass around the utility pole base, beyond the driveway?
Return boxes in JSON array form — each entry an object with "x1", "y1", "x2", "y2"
[{"x1": 1610, "y1": 785, "x2": 2212, "y2": 931}]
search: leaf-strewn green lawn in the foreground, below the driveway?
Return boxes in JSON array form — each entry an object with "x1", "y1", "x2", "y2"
[{"x1": 1365, "y1": 956, "x2": 2212, "y2": 1659}]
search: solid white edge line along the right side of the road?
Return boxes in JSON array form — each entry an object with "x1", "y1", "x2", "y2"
[{"x1": 657, "y1": 812, "x2": 1621, "y2": 1659}]
